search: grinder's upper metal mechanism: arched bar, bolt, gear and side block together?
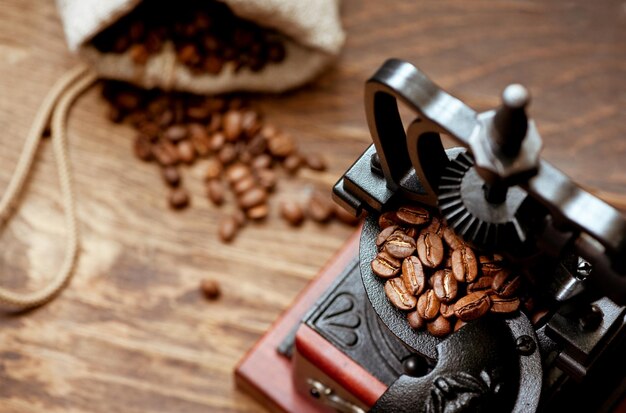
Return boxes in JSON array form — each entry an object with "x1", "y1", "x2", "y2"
[{"x1": 334, "y1": 59, "x2": 626, "y2": 304}]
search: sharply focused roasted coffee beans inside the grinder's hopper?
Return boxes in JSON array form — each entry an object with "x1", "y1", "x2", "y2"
[{"x1": 371, "y1": 205, "x2": 533, "y2": 337}]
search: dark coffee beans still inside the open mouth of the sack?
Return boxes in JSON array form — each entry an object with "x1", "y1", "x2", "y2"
[{"x1": 92, "y1": 0, "x2": 286, "y2": 75}]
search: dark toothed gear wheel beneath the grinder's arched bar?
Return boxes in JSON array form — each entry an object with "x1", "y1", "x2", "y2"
[{"x1": 439, "y1": 152, "x2": 526, "y2": 249}]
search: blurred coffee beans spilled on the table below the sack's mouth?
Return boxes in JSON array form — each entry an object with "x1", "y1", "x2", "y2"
[{"x1": 103, "y1": 81, "x2": 358, "y2": 242}]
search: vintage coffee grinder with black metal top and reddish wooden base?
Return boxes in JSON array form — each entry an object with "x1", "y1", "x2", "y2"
[{"x1": 236, "y1": 60, "x2": 626, "y2": 413}]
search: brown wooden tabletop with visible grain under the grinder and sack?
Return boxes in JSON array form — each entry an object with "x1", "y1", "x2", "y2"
[{"x1": 0, "y1": 0, "x2": 626, "y2": 412}]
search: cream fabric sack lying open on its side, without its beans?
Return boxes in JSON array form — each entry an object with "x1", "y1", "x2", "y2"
[{"x1": 57, "y1": 0, "x2": 345, "y2": 94}]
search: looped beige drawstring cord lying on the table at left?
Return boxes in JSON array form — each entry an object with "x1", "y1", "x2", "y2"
[{"x1": 0, "y1": 65, "x2": 96, "y2": 311}]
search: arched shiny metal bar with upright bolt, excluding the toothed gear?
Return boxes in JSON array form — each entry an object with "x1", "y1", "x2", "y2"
[{"x1": 352, "y1": 59, "x2": 626, "y2": 303}]
